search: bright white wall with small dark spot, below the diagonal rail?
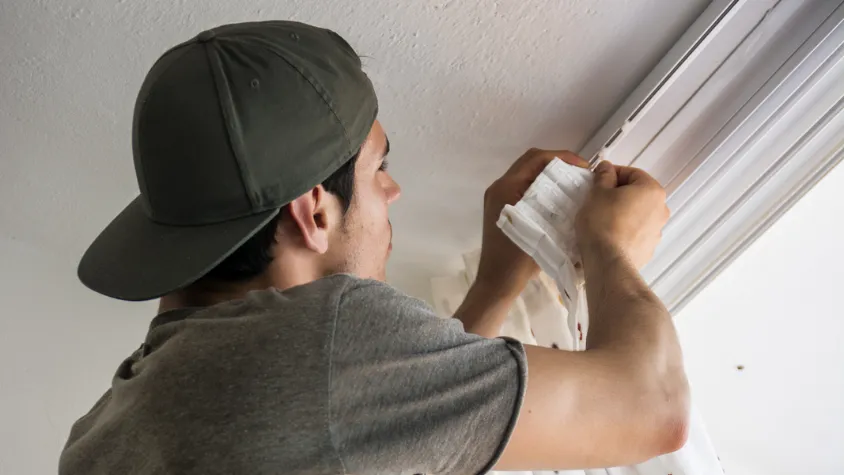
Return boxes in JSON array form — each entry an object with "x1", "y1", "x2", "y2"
[{"x1": 676, "y1": 165, "x2": 844, "y2": 475}]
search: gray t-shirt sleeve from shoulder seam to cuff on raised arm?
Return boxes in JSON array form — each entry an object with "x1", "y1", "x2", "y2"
[{"x1": 329, "y1": 281, "x2": 527, "y2": 474}]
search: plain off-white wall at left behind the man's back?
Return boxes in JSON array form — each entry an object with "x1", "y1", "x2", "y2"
[{"x1": 0, "y1": 240, "x2": 155, "y2": 475}]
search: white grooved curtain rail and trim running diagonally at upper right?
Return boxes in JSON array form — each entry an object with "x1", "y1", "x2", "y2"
[{"x1": 581, "y1": 0, "x2": 844, "y2": 313}]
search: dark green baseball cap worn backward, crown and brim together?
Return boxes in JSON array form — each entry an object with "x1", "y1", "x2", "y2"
[{"x1": 78, "y1": 21, "x2": 378, "y2": 300}]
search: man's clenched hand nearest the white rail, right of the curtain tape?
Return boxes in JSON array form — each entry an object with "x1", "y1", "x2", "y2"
[{"x1": 577, "y1": 162, "x2": 670, "y2": 269}]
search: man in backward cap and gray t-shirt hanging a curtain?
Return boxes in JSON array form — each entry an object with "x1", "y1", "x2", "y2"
[{"x1": 60, "y1": 22, "x2": 688, "y2": 474}]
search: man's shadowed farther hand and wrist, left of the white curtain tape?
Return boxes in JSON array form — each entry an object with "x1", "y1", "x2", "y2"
[{"x1": 477, "y1": 148, "x2": 589, "y2": 298}]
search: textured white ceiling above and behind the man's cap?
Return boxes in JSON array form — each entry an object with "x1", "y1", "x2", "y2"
[{"x1": 0, "y1": 0, "x2": 708, "y2": 297}]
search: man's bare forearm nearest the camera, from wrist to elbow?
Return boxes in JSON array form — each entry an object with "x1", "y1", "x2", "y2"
[{"x1": 581, "y1": 238, "x2": 689, "y2": 453}]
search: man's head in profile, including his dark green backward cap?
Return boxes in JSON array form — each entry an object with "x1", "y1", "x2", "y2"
[{"x1": 78, "y1": 21, "x2": 399, "y2": 302}]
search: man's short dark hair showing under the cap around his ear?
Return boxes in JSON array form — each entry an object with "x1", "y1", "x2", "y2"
[{"x1": 202, "y1": 151, "x2": 360, "y2": 282}]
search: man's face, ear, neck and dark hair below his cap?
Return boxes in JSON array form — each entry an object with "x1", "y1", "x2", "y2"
[{"x1": 205, "y1": 121, "x2": 400, "y2": 286}]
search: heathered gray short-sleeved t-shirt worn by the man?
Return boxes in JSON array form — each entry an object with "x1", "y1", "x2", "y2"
[{"x1": 59, "y1": 275, "x2": 527, "y2": 475}]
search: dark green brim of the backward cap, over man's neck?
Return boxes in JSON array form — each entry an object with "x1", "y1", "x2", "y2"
[{"x1": 78, "y1": 197, "x2": 279, "y2": 301}]
